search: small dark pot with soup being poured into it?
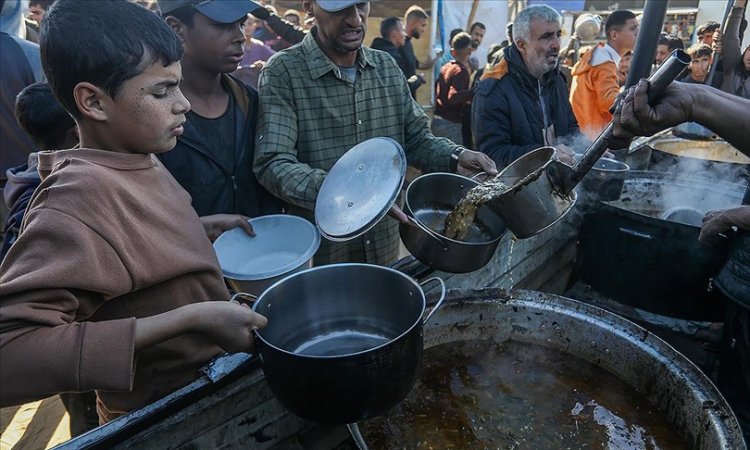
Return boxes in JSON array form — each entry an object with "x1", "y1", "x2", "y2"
[{"x1": 399, "y1": 173, "x2": 506, "y2": 273}]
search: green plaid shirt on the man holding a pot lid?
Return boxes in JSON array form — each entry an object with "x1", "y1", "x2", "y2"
[{"x1": 254, "y1": 31, "x2": 457, "y2": 265}]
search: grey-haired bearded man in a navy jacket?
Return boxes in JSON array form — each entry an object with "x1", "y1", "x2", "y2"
[{"x1": 472, "y1": 5, "x2": 578, "y2": 167}]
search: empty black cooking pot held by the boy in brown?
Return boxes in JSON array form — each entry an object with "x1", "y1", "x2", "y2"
[{"x1": 253, "y1": 264, "x2": 445, "y2": 424}]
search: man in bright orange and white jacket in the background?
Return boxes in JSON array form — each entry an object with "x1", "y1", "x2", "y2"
[{"x1": 570, "y1": 10, "x2": 638, "y2": 140}]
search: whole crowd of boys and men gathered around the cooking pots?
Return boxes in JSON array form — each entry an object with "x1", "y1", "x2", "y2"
[{"x1": 0, "y1": 0, "x2": 750, "y2": 444}]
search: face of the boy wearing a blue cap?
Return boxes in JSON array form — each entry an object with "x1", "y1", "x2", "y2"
[{"x1": 181, "y1": 13, "x2": 246, "y2": 73}]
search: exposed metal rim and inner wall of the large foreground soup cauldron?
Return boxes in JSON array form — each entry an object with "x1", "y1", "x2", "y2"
[{"x1": 356, "y1": 289, "x2": 747, "y2": 450}]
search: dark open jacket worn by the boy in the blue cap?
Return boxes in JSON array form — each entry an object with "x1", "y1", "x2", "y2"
[{"x1": 158, "y1": 75, "x2": 282, "y2": 217}]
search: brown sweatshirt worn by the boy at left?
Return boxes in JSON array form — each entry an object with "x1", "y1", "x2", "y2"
[{"x1": 0, "y1": 149, "x2": 229, "y2": 420}]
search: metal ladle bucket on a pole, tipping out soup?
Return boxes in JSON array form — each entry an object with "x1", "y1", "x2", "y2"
[{"x1": 487, "y1": 147, "x2": 577, "y2": 239}]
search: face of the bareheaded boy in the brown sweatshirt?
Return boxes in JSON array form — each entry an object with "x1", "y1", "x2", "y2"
[{"x1": 104, "y1": 62, "x2": 190, "y2": 153}]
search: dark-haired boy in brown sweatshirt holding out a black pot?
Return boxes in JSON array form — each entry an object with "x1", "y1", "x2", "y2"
[{"x1": 0, "y1": 0, "x2": 265, "y2": 421}]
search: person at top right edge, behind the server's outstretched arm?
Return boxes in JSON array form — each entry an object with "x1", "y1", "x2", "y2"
[{"x1": 714, "y1": 0, "x2": 750, "y2": 99}]
